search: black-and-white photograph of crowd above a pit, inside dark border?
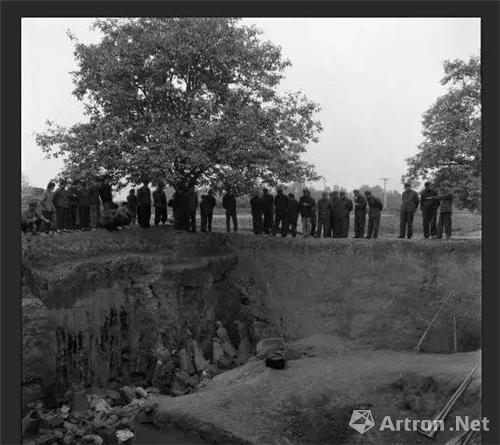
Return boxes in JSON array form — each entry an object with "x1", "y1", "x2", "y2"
[{"x1": 20, "y1": 14, "x2": 484, "y2": 445}]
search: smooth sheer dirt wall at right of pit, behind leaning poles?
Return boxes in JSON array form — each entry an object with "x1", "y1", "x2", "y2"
[{"x1": 228, "y1": 236, "x2": 481, "y2": 352}]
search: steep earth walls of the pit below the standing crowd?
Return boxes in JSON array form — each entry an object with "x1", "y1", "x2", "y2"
[{"x1": 23, "y1": 234, "x2": 481, "y2": 444}]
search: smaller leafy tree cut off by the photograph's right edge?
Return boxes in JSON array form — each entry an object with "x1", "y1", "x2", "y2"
[{"x1": 407, "y1": 57, "x2": 481, "y2": 209}]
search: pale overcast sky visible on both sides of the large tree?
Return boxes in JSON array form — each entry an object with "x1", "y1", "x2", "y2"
[{"x1": 22, "y1": 18, "x2": 480, "y2": 190}]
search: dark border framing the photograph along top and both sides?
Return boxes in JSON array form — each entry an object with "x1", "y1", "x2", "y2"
[{"x1": 0, "y1": 0, "x2": 500, "y2": 445}]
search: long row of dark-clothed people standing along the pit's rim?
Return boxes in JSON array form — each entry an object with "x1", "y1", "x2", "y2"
[{"x1": 21, "y1": 176, "x2": 453, "y2": 239}]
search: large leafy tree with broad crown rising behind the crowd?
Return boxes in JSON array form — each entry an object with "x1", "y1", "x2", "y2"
[{"x1": 36, "y1": 18, "x2": 321, "y2": 192}]
